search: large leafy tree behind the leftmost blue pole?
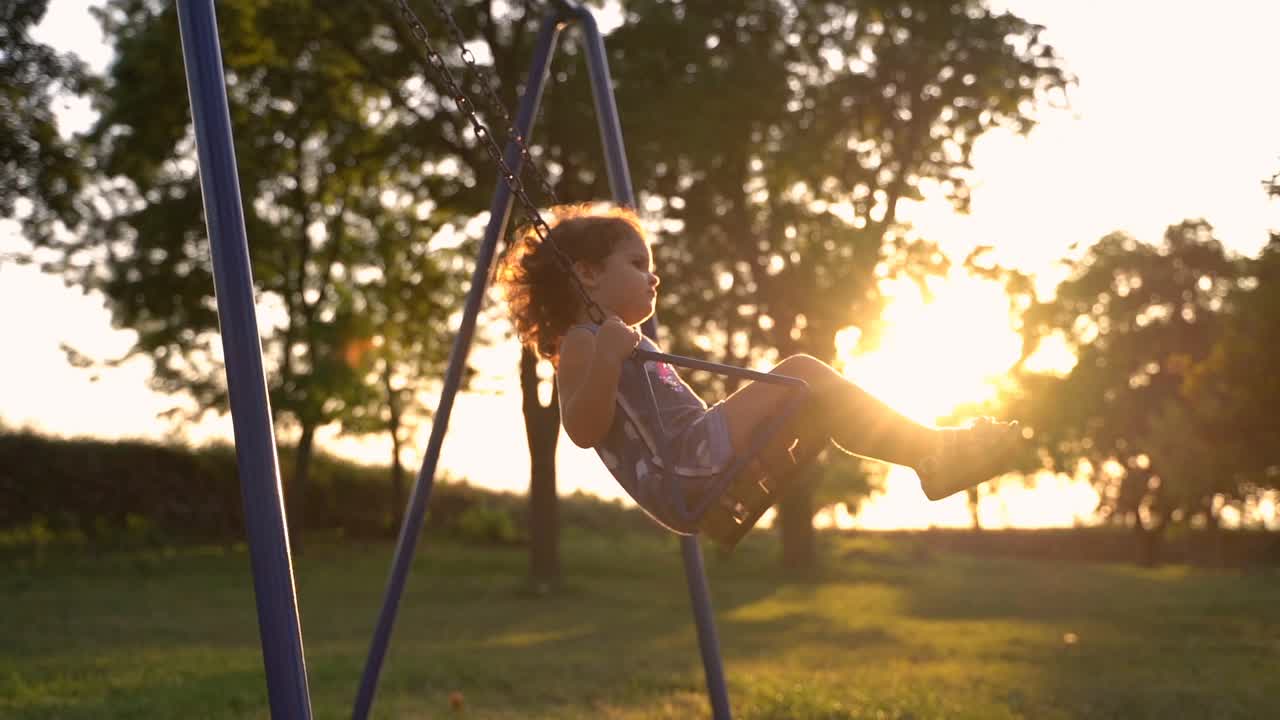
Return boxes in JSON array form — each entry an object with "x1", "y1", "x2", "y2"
[{"x1": 27, "y1": 0, "x2": 477, "y2": 545}]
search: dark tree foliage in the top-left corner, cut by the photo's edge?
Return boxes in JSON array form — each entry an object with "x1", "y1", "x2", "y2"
[{"x1": 0, "y1": 0, "x2": 92, "y2": 225}]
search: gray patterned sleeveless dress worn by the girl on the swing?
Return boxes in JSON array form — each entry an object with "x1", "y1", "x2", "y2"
[{"x1": 565, "y1": 324, "x2": 733, "y2": 533}]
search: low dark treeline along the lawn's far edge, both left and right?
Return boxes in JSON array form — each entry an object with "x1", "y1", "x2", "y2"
[{"x1": 0, "y1": 432, "x2": 1280, "y2": 566}]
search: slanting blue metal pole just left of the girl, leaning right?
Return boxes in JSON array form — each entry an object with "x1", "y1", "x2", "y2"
[{"x1": 352, "y1": 12, "x2": 561, "y2": 720}]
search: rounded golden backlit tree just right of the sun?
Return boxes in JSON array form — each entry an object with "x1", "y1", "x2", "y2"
[{"x1": 1014, "y1": 220, "x2": 1240, "y2": 564}]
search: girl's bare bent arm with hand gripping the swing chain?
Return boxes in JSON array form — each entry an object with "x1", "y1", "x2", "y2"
[{"x1": 556, "y1": 319, "x2": 640, "y2": 447}]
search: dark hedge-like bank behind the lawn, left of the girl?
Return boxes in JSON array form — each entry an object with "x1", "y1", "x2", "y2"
[{"x1": 0, "y1": 432, "x2": 650, "y2": 550}]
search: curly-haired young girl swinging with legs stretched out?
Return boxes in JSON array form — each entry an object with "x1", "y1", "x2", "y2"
[{"x1": 498, "y1": 206, "x2": 1020, "y2": 533}]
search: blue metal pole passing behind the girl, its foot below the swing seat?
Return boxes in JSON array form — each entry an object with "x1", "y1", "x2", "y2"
[{"x1": 566, "y1": 3, "x2": 731, "y2": 720}]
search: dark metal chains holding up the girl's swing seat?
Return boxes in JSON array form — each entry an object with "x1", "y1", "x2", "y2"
[{"x1": 397, "y1": 0, "x2": 605, "y2": 324}]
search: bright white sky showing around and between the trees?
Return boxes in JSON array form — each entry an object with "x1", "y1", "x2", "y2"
[{"x1": 0, "y1": 0, "x2": 1280, "y2": 528}]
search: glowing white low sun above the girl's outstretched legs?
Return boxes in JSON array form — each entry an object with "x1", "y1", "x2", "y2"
[{"x1": 836, "y1": 270, "x2": 1021, "y2": 424}]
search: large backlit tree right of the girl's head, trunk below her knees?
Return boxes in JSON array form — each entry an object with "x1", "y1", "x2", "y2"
[{"x1": 599, "y1": 0, "x2": 1069, "y2": 566}]
